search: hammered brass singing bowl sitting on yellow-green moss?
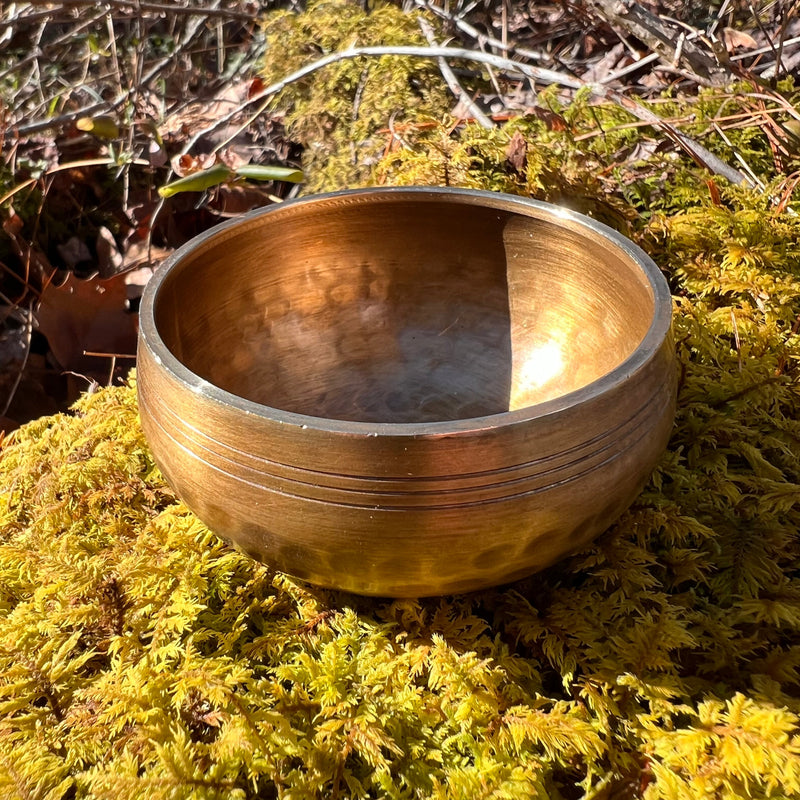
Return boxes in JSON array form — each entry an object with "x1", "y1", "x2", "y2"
[{"x1": 138, "y1": 188, "x2": 676, "y2": 597}]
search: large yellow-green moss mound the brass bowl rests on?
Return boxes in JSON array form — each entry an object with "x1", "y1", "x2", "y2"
[{"x1": 0, "y1": 6, "x2": 800, "y2": 800}]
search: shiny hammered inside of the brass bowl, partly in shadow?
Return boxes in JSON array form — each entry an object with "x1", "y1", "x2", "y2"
[{"x1": 154, "y1": 193, "x2": 655, "y2": 423}]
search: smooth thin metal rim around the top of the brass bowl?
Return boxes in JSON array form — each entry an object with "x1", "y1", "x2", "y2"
[{"x1": 138, "y1": 186, "x2": 672, "y2": 438}]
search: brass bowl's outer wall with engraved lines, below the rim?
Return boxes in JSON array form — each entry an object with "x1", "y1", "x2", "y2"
[{"x1": 138, "y1": 328, "x2": 676, "y2": 597}]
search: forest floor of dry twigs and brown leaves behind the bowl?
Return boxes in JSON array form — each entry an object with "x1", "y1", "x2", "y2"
[{"x1": 0, "y1": 0, "x2": 800, "y2": 431}]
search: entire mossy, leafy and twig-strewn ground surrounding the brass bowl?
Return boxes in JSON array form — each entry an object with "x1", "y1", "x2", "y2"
[{"x1": 0, "y1": 0, "x2": 800, "y2": 800}]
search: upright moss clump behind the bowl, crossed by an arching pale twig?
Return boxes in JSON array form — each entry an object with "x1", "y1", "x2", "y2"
[{"x1": 264, "y1": 0, "x2": 453, "y2": 192}]
